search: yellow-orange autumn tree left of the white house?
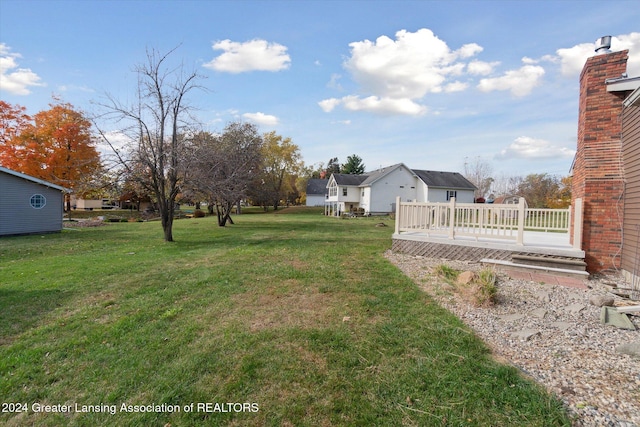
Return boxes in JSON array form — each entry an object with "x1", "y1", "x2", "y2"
[{"x1": 251, "y1": 131, "x2": 303, "y2": 210}]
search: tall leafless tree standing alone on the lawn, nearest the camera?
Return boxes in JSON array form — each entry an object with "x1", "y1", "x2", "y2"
[{"x1": 95, "y1": 49, "x2": 201, "y2": 242}]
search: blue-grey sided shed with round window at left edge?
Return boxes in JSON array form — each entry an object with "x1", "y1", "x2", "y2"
[{"x1": 0, "y1": 167, "x2": 69, "y2": 236}]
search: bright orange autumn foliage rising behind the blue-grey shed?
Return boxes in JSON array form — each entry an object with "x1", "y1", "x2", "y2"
[{"x1": 0, "y1": 103, "x2": 102, "y2": 210}]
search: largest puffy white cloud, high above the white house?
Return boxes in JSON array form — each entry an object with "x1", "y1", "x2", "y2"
[{"x1": 318, "y1": 28, "x2": 484, "y2": 116}]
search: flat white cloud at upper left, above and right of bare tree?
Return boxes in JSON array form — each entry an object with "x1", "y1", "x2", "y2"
[{"x1": 203, "y1": 39, "x2": 291, "y2": 73}]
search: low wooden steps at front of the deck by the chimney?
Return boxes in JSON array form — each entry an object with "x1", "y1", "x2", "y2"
[{"x1": 480, "y1": 253, "x2": 589, "y2": 279}]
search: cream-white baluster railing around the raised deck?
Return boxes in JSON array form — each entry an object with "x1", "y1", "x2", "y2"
[{"x1": 396, "y1": 198, "x2": 582, "y2": 249}]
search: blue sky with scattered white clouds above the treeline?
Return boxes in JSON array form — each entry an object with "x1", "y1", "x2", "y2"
[{"x1": 0, "y1": 0, "x2": 640, "y2": 176}]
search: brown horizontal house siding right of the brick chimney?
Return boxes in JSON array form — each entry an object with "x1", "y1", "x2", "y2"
[{"x1": 621, "y1": 95, "x2": 640, "y2": 281}]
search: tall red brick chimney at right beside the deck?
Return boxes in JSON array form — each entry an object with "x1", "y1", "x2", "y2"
[{"x1": 572, "y1": 50, "x2": 629, "y2": 273}]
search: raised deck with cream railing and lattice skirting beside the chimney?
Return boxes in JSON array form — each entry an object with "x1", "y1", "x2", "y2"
[{"x1": 392, "y1": 198, "x2": 585, "y2": 261}]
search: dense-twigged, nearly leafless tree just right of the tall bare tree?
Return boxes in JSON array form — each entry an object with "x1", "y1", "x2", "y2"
[{"x1": 189, "y1": 123, "x2": 262, "y2": 227}]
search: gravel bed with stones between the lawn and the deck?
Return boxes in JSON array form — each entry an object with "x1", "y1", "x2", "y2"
[{"x1": 385, "y1": 251, "x2": 640, "y2": 427}]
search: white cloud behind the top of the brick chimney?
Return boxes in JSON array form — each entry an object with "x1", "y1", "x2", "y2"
[{"x1": 553, "y1": 32, "x2": 640, "y2": 77}]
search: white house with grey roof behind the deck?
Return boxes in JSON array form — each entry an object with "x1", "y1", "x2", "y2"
[{"x1": 325, "y1": 163, "x2": 476, "y2": 216}]
